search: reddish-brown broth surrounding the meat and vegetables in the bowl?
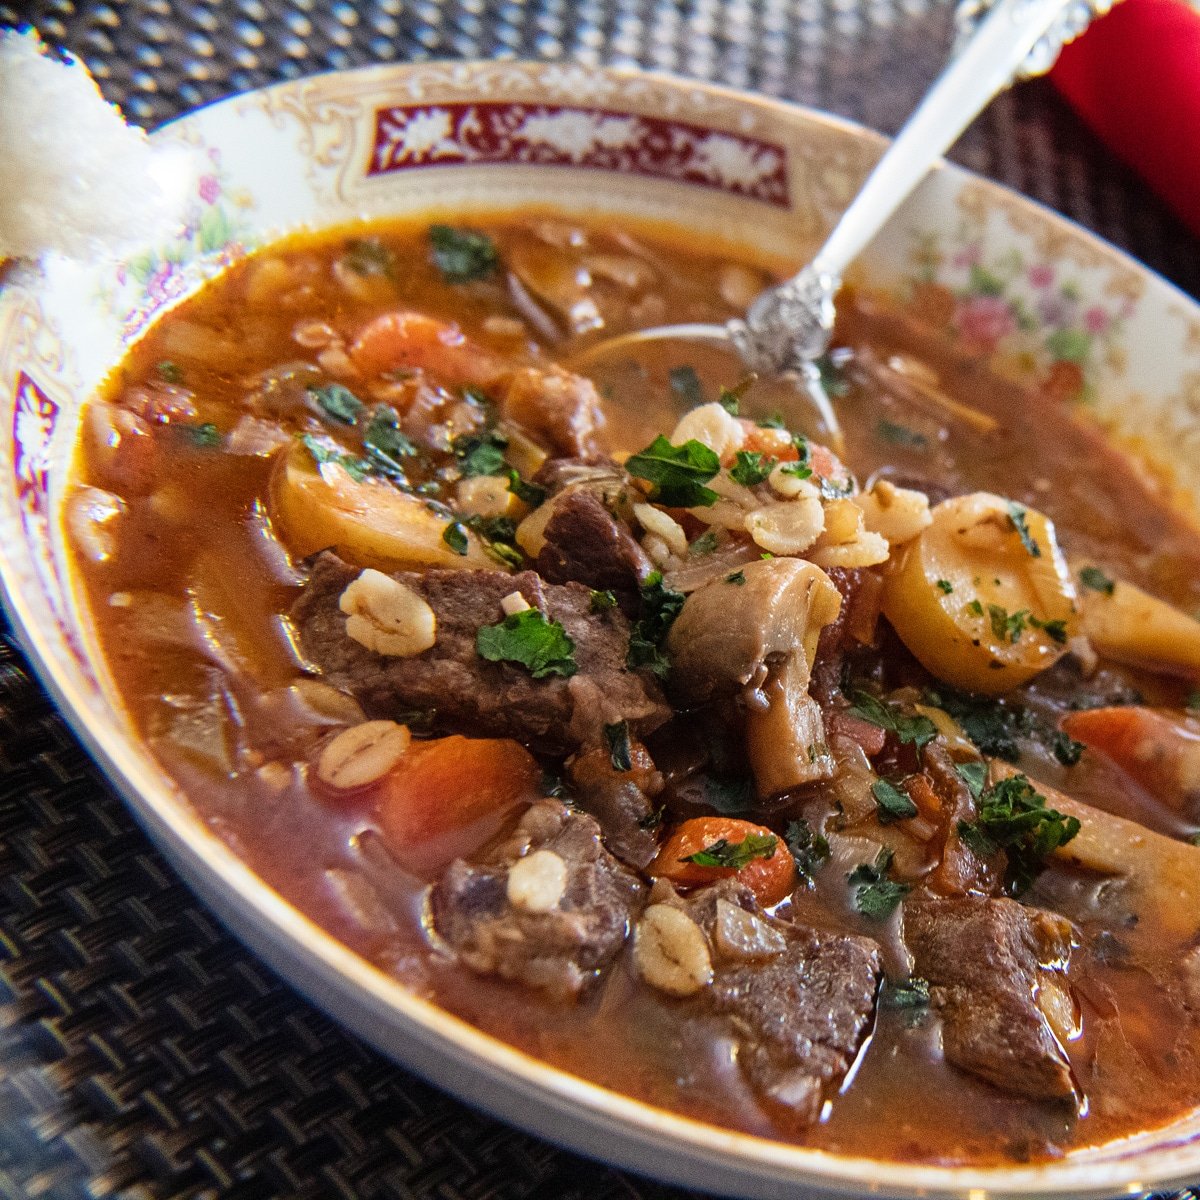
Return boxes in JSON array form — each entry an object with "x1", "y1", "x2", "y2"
[{"x1": 70, "y1": 218, "x2": 1200, "y2": 1164}]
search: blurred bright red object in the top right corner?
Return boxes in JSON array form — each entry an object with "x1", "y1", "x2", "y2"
[{"x1": 1050, "y1": 0, "x2": 1200, "y2": 235}]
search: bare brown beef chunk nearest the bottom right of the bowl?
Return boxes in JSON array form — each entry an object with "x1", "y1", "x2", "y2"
[{"x1": 904, "y1": 896, "x2": 1075, "y2": 1099}]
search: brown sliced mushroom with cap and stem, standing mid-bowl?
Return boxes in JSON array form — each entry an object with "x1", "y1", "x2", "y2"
[{"x1": 667, "y1": 558, "x2": 841, "y2": 798}]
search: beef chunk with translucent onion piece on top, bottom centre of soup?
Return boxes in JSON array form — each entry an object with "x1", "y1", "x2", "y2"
[{"x1": 652, "y1": 880, "x2": 882, "y2": 1130}]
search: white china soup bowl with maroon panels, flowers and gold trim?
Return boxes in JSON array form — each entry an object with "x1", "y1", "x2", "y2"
[{"x1": 0, "y1": 62, "x2": 1200, "y2": 1198}]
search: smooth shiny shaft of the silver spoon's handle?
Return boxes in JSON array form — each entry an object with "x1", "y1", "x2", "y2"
[{"x1": 810, "y1": 0, "x2": 1099, "y2": 281}]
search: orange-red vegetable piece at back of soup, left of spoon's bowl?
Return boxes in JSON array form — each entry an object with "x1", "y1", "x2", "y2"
[{"x1": 350, "y1": 312, "x2": 511, "y2": 388}]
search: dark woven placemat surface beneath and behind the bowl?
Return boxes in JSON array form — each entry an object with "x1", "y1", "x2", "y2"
[{"x1": 0, "y1": 0, "x2": 1200, "y2": 1200}]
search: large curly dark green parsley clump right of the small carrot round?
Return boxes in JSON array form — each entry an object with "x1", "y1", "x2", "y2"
[{"x1": 958, "y1": 775, "x2": 1080, "y2": 895}]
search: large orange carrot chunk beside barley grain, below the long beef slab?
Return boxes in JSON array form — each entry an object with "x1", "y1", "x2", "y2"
[{"x1": 376, "y1": 737, "x2": 541, "y2": 856}]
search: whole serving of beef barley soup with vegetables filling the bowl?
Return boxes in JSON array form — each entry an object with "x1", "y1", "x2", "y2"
[{"x1": 66, "y1": 212, "x2": 1200, "y2": 1164}]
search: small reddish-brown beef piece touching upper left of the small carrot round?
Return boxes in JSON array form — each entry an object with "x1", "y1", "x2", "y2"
[{"x1": 568, "y1": 743, "x2": 664, "y2": 870}]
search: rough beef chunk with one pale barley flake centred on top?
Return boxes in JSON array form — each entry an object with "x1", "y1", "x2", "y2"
[{"x1": 432, "y1": 800, "x2": 644, "y2": 1001}]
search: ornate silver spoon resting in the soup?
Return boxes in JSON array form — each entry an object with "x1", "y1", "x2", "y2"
[{"x1": 576, "y1": 0, "x2": 1114, "y2": 442}]
